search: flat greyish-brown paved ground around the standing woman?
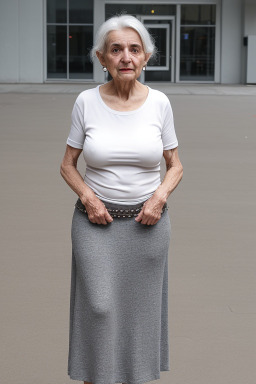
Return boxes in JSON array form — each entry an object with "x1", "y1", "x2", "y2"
[{"x1": 0, "y1": 85, "x2": 256, "y2": 384}]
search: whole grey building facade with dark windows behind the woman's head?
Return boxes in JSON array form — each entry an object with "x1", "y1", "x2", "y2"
[{"x1": 0, "y1": 0, "x2": 256, "y2": 84}]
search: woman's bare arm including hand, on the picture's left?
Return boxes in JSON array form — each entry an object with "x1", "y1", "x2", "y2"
[{"x1": 60, "y1": 145, "x2": 113, "y2": 224}]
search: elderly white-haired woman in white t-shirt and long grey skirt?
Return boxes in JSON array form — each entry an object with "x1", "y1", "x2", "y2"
[{"x1": 61, "y1": 15, "x2": 183, "y2": 384}]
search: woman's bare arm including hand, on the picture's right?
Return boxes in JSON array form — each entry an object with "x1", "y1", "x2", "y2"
[{"x1": 135, "y1": 147, "x2": 183, "y2": 225}]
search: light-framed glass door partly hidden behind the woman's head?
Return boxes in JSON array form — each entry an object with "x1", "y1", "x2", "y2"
[{"x1": 141, "y1": 16, "x2": 174, "y2": 82}]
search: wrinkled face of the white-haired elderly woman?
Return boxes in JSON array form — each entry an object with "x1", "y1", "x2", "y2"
[{"x1": 97, "y1": 28, "x2": 150, "y2": 81}]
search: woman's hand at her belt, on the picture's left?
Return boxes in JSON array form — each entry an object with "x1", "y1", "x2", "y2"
[{"x1": 80, "y1": 191, "x2": 113, "y2": 225}]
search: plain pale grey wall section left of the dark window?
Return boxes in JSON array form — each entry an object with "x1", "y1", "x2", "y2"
[{"x1": 0, "y1": 0, "x2": 43, "y2": 83}]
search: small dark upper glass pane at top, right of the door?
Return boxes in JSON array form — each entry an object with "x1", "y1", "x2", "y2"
[{"x1": 181, "y1": 5, "x2": 216, "y2": 25}]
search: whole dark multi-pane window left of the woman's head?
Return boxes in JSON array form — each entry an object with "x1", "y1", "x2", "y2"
[{"x1": 47, "y1": 0, "x2": 93, "y2": 79}]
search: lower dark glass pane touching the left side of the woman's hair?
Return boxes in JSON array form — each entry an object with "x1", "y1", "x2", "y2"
[{"x1": 69, "y1": 25, "x2": 93, "y2": 79}]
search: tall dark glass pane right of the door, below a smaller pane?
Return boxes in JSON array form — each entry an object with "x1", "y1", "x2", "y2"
[{"x1": 180, "y1": 27, "x2": 215, "y2": 81}]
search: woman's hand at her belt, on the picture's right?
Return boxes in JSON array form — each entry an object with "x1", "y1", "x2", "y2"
[{"x1": 135, "y1": 194, "x2": 165, "y2": 225}]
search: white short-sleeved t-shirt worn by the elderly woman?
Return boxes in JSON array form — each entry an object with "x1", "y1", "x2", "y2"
[{"x1": 67, "y1": 86, "x2": 178, "y2": 205}]
